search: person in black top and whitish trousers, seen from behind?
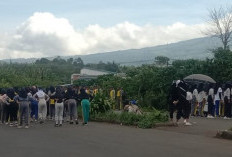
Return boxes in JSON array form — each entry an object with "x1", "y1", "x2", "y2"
[{"x1": 54, "y1": 87, "x2": 64, "y2": 127}]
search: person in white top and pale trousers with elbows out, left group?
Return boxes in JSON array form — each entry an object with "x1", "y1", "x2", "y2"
[{"x1": 33, "y1": 89, "x2": 49, "y2": 124}]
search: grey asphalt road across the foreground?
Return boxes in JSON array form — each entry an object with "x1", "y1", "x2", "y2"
[{"x1": 0, "y1": 118, "x2": 232, "y2": 157}]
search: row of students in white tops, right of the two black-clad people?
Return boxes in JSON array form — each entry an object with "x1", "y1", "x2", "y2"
[{"x1": 191, "y1": 83, "x2": 232, "y2": 119}]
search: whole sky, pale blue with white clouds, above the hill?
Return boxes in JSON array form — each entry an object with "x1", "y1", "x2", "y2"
[{"x1": 0, "y1": 0, "x2": 232, "y2": 59}]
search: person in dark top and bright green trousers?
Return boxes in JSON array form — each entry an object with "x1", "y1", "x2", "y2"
[{"x1": 78, "y1": 88, "x2": 91, "y2": 125}]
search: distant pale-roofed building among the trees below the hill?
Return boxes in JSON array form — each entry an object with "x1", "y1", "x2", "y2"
[{"x1": 71, "y1": 68, "x2": 114, "y2": 84}]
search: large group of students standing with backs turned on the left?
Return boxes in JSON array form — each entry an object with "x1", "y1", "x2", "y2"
[{"x1": 0, "y1": 86, "x2": 92, "y2": 128}]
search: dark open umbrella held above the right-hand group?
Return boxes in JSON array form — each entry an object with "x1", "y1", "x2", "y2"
[{"x1": 184, "y1": 74, "x2": 216, "y2": 83}]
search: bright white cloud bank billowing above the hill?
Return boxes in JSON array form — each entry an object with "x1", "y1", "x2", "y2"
[{"x1": 0, "y1": 13, "x2": 208, "y2": 59}]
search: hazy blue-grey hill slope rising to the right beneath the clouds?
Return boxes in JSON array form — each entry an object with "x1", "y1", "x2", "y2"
[{"x1": 1, "y1": 37, "x2": 222, "y2": 65}]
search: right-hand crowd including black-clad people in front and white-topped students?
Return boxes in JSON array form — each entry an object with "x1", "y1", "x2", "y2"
[{"x1": 169, "y1": 80, "x2": 232, "y2": 125}]
